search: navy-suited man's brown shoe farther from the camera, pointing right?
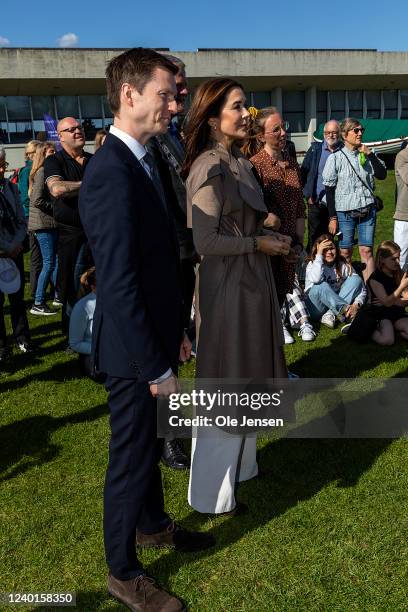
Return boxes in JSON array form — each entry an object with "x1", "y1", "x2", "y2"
[{"x1": 136, "y1": 521, "x2": 215, "y2": 552}]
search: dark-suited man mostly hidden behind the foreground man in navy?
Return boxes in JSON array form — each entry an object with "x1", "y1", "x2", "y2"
[{"x1": 147, "y1": 54, "x2": 194, "y2": 469}]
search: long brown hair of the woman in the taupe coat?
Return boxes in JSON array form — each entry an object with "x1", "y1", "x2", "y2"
[{"x1": 181, "y1": 78, "x2": 243, "y2": 180}]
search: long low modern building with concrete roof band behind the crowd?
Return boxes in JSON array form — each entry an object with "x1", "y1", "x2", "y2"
[{"x1": 0, "y1": 48, "x2": 408, "y2": 166}]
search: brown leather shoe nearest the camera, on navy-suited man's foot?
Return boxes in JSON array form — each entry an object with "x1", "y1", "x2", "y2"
[{"x1": 108, "y1": 574, "x2": 186, "y2": 612}]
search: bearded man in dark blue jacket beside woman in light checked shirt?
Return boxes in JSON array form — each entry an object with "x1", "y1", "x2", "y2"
[{"x1": 300, "y1": 119, "x2": 343, "y2": 253}]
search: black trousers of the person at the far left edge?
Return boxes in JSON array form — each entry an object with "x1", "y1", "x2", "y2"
[{"x1": 0, "y1": 253, "x2": 30, "y2": 348}]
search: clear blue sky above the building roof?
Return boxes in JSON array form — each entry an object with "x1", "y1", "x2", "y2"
[{"x1": 0, "y1": 0, "x2": 408, "y2": 51}]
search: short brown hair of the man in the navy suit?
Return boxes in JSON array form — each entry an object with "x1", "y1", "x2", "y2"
[{"x1": 106, "y1": 47, "x2": 178, "y2": 114}]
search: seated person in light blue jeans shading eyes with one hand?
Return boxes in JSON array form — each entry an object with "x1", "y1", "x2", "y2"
[{"x1": 305, "y1": 234, "x2": 366, "y2": 331}]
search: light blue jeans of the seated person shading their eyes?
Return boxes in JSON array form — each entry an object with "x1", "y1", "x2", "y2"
[{"x1": 306, "y1": 274, "x2": 363, "y2": 321}]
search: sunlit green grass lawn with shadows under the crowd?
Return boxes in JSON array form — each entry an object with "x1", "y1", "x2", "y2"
[{"x1": 0, "y1": 173, "x2": 408, "y2": 612}]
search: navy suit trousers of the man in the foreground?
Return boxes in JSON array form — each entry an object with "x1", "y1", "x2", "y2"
[{"x1": 104, "y1": 376, "x2": 171, "y2": 580}]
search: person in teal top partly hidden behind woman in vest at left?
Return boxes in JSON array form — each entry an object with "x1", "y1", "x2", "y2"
[{"x1": 18, "y1": 140, "x2": 42, "y2": 301}]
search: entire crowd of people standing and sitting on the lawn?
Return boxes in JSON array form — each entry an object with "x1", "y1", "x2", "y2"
[{"x1": 0, "y1": 49, "x2": 408, "y2": 611}]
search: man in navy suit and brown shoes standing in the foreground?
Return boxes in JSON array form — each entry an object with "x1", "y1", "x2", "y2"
[{"x1": 79, "y1": 49, "x2": 213, "y2": 612}]
